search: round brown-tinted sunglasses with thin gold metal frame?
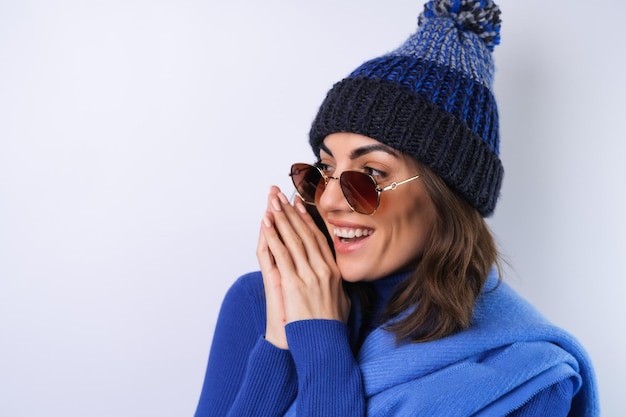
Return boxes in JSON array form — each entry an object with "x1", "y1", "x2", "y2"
[{"x1": 289, "y1": 163, "x2": 420, "y2": 215}]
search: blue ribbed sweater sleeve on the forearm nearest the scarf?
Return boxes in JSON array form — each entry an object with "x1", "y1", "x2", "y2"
[{"x1": 286, "y1": 319, "x2": 365, "y2": 417}]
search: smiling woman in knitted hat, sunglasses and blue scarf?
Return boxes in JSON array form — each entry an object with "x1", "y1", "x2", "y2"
[{"x1": 196, "y1": 0, "x2": 598, "y2": 416}]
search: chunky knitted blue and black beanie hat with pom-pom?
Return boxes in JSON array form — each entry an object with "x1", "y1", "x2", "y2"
[{"x1": 309, "y1": 0, "x2": 504, "y2": 217}]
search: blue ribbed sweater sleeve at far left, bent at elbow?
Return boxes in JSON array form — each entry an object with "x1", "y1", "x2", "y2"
[{"x1": 195, "y1": 273, "x2": 297, "y2": 417}]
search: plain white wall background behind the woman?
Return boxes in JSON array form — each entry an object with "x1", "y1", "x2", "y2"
[{"x1": 0, "y1": 0, "x2": 626, "y2": 417}]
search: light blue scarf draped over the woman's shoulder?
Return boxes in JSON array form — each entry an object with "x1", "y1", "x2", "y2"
[{"x1": 287, "y1": 271, "x2": 599, "y2": 417}]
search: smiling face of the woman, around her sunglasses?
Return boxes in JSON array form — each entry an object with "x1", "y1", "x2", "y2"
[{"x1": 317, "y1": 133, "x2": 436, "y2": 282}]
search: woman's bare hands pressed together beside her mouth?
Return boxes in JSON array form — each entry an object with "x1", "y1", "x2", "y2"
[{"x1": 257, "y1": 187, "x2": 350, "y2": 349}]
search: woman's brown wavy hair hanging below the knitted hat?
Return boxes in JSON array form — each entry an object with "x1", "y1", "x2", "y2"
[{"x1": 382, "y1": 159, "x2": 500, "y2": 342}]
